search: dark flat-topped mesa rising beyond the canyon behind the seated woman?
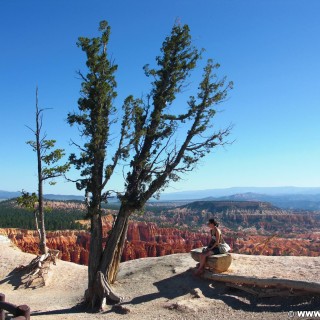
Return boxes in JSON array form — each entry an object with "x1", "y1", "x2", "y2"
[{"x1": 168, "y1": 200, "x2": 320, "y2": 234}]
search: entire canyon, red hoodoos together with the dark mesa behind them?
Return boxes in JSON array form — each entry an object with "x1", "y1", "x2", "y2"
[{"x1": 0, "y1": 201, "x2": 320, "y2": 265}]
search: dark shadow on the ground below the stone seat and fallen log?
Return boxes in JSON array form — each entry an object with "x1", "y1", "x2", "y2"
[{"x1": 121, "y1": 269, "x2": 320, "y2": 313}]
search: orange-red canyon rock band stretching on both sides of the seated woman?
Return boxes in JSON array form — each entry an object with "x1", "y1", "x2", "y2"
[{"x1": 0, "y1": 216, "x2": 320, "y2": 265}]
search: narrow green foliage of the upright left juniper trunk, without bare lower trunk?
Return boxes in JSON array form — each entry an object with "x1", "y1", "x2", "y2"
[{"x1": 68, "y1": 21, "x2": 129, "y2": 207}]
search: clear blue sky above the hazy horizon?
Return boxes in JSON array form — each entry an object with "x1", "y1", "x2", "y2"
[{"x1": 0, "y1": 0, "x2": 320, "y2": 194}]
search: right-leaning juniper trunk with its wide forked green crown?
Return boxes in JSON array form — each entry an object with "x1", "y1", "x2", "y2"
[{"x1": 101, "y1": 25, "x2": 233, "y2": 283}]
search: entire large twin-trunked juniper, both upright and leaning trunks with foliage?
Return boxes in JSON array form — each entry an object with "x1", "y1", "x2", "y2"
[{"x1": 68, "y1": 21, "x2": 232, "y2": 307}]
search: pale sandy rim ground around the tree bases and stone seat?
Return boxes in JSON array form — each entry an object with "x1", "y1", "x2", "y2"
[{"x1": 0, "y1": 235, "x2": 320, "y2": 320}]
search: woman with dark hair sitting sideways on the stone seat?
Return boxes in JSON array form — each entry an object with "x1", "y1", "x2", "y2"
[{"x1": 195, "y1": 218, "x2": 221, "y2": 275}]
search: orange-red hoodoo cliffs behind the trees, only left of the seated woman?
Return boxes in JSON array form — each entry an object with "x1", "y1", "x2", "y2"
[{"x1": 0, "y1": 218, "x2": 210, "y2": 265}]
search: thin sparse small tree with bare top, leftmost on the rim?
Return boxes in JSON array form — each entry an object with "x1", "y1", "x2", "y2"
[{"x1": 23, "y1": 87, "x2": 70, "y2": 254}]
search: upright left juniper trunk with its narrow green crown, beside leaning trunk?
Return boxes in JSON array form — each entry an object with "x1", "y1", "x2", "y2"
[{"x1": 68, "y1": 21, "x2": 129, "y2": 305}]
